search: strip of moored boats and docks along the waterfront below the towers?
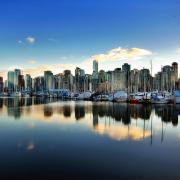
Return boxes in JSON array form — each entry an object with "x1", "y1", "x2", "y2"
[{"x1": 0, "y1": 89, "x2": 180, "y2": 104}]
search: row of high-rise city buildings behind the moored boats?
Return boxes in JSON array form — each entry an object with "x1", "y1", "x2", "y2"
[{"x1": 0, "y1": 60, "x2": 180, "y2": 95}]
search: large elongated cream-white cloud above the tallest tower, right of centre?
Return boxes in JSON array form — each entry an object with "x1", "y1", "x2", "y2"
[{"x1": 91, "y1": 47, "x2": 153, "y2": 62}]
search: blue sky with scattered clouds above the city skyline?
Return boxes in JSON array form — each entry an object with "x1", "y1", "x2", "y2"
[{"x1": 0, "y1": 0, "x2": 180, "y2": 77}]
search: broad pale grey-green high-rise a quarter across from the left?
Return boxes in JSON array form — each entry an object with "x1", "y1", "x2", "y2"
[{"x1": 44, "y1": 71, "x2": 54, "y2": 91}]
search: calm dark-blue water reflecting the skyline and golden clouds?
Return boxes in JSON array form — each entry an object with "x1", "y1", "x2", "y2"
[{"x1": 0, "y1": 98, "x2": 180, "y2": 180}]
